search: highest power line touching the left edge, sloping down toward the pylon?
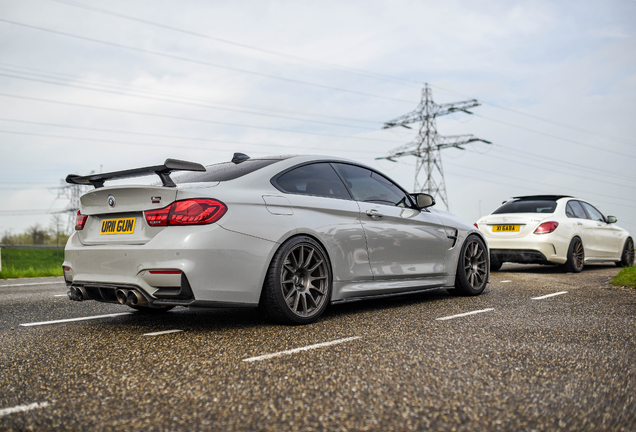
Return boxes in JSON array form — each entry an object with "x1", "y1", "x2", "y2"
[{"x1": 0, "y1": 18, "x2": 410, "y2": 103}]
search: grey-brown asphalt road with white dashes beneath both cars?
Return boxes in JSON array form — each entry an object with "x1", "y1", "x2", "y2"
[{"x1": 0, "y1": 264, "x2": 636, "y2": 431}]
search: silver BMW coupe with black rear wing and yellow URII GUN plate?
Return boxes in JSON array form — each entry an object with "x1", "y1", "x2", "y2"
[{"x1": 63, "y1": 153, "x2": 490, "y2": 324}]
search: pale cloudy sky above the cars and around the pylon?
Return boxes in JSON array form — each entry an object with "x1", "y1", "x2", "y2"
[{"x1": 0, "y1": 0, "x2": 636, "y2": 234}]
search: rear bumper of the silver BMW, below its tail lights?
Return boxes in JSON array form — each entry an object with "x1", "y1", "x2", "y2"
[{"x1": 63, "y1": 224, "x2": 276, "y2": 307}]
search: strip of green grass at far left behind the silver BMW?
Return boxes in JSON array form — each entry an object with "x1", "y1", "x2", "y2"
[{"x1": 0, "y1": 249, "x2": 64, "y2": 279}]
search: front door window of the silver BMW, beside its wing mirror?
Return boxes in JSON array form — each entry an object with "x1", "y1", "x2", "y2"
[{"x1": 333, "y1": 164, "x2": 411, "y2": 207}]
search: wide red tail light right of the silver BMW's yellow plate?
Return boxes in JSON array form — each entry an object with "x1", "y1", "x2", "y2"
[{"x1": 144, "y1": 198, "x2": 227, "y2": 226}]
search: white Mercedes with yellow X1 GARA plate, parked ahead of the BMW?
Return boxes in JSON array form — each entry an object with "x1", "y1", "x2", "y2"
[{"x1": 475, "y1": 195, "x2": 634, "y2": 273}]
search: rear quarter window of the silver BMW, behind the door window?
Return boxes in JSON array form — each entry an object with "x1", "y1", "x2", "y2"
[{"x1": 276, "y1": 163, "x2": 351, "y2": 200}]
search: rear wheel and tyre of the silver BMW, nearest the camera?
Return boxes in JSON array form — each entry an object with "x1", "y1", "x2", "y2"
[{"x1": 261, "y1": 236, "x2": 332, "y2": 324}]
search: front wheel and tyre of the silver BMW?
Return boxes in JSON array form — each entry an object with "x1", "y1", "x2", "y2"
[{"x1": 455, "y1": 234, "x2": 490, "y2": 296}]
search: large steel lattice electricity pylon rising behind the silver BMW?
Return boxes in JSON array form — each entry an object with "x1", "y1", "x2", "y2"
[{"x1": 376, "y1": 84, "x2": 492, "y2": 210}]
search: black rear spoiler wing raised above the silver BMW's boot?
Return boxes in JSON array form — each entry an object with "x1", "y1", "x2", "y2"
[{"x1": 66, "y1": 159, "x2": 205, "y2": 189}]
